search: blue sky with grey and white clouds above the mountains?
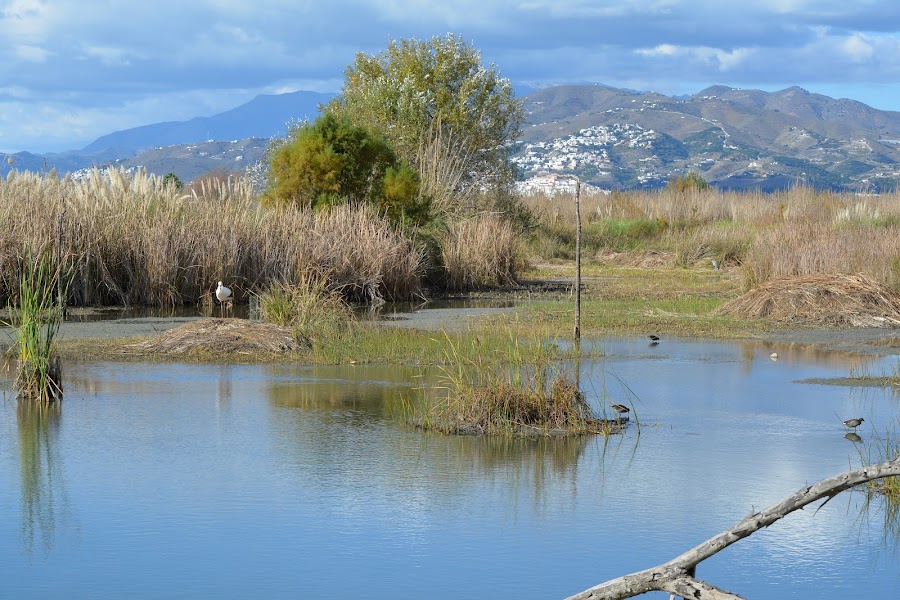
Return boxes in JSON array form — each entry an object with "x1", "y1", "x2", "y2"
[{"x1": 0, "y1": 0, "x2": 900, "y2": 152}]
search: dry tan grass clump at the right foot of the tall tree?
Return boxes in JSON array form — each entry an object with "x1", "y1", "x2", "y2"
[{"x1": 441, "y1": 214, "x2": 519, "y2": 290}]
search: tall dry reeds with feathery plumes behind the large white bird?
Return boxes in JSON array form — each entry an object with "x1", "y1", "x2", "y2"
[{"x1": 0, "y1": 170, "x2": 423, "y2": 305}]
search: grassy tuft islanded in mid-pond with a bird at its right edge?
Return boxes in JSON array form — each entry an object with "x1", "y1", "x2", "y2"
[{"x1": 410, "y1": 337, "x2": 624, "y2": 436}]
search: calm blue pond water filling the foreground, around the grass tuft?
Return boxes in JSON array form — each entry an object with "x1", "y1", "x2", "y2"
[{"x1": 0, "y1": 339, "x2": 900, "y2": 599}]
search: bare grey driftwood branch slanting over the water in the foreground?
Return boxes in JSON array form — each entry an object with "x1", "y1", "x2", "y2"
[{"x1": 567, "y1": 456, "x2": 900, "y2": 600}]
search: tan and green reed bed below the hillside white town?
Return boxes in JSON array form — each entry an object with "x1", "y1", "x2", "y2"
[{"x1": 523, "y1": 186, "x2": 900, "y2": 289}]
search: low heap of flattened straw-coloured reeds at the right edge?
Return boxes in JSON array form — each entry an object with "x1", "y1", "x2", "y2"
[{"x1": 719, "y1": 274, "x2": 900, "y2": 327}]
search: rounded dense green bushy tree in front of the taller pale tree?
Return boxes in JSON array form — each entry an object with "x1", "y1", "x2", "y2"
[{"x1": 264, "y1": 113, "x2": 427, "y2": 221}]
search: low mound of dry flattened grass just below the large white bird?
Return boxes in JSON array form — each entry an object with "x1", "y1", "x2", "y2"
[{"x1": 128, "y1": 319, "x2": 307, "y2": 358}]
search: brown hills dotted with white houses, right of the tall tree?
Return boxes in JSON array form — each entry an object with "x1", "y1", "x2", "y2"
[{"x1": 514, "y1": 85, "x2": 900, "y2": 191}]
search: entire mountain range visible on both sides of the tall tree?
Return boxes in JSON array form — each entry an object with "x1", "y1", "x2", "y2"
[{"x1": 0, "y1": 85, "x2": 900, "y2": 192}]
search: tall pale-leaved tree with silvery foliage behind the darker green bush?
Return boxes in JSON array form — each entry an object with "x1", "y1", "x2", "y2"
[{"x1": 328, "y1": 34, "x2": 525, "y2": 203}]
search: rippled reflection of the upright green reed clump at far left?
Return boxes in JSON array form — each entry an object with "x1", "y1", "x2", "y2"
[{"x1": 16, "y1": 400, "x2": 69, "y2": 554}]
